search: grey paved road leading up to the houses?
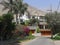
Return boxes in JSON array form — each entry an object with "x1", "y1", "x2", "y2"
[{"x1": 26, "y1": 37, "x2": 55, "y2": 45}]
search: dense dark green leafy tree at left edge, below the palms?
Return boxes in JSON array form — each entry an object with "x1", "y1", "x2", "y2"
[{"x1": 0, "y1": 13, "x2": 15, "y2": 40}]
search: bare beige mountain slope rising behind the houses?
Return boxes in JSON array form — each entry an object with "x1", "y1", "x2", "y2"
[{"x1": 27, "y1": 6, "x2": 46, "y2": 16}]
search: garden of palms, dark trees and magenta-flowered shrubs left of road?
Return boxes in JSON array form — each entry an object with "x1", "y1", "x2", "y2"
[{"x1": 0, "y1": 0, "x2": 35, "y2": 42}]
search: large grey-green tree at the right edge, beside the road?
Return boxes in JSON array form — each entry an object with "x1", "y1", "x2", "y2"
[{"x1": 45, "y1": 11, "x2": 60, "y2": 36}]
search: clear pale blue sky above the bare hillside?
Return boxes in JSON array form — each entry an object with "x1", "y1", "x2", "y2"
[{"x1": 24, "y1": 0, "x2": 59, "y2": 11}]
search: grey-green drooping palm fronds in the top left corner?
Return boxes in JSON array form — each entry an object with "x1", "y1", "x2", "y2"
[{"x1": 0, "y1": 0, "x2": 13, "y2": 12}]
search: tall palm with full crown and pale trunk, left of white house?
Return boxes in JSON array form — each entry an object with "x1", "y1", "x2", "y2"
[{"x1": 13, "y1": 0, "x2": 28, "y2": 23}]
